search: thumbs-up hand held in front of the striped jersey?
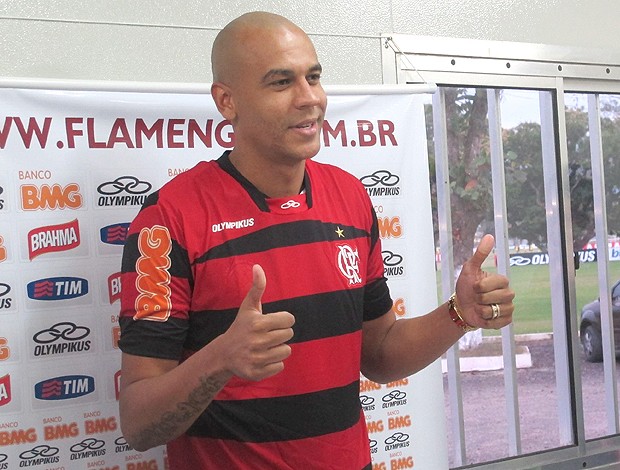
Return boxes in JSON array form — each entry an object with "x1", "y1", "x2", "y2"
[{"x1": 219, "y1": 264, "x2": 295, "y2": 381}]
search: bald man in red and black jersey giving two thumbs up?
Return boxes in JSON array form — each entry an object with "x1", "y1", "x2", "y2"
[{"x1": 120, "y1": 12, "x2": 514, "y2": 470}]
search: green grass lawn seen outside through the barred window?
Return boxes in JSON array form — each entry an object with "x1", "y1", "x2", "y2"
[{"x1": 485, "y1": 261, "x2": 620, "y2": 335}]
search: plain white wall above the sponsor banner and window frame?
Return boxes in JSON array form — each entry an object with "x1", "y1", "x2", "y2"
[{"x1": 0, "y1": 0, "x2": 620, "y2": 84}]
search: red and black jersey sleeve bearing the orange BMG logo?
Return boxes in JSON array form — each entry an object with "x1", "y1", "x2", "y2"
[{"x1": 119, "y1": 192, "x2": 193, "y2": 360}]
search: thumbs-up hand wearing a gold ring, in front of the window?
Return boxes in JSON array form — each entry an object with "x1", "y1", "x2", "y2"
[{"x1": 456, "y1": 234, "x2": 515, "y2": 329}]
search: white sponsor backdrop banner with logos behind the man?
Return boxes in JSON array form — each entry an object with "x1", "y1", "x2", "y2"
[{"x1": 0, "y1": 89, "x2": 448, "y2": 470}]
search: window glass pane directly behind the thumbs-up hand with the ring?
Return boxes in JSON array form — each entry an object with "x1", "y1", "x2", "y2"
[{"x1": 427, "y1": 88, "x2": 560, "y2": 466}]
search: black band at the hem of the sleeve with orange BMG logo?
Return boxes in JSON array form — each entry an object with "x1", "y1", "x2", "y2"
[{"x1": 118, "y1": 317, "x2": 189, "y2": 361}]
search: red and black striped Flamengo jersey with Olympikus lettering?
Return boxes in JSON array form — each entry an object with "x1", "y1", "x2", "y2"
[{"x1": 119, "y1": 153, "x2": 392, "y2": 469}]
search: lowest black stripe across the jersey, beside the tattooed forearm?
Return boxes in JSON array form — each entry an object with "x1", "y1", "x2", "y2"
[{"x1": 187, "y1": 380, "x2": 360, "y2": 442}]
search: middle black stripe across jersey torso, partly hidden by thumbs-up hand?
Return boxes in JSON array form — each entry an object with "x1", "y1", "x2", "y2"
[{"x1": 186, "y1": 288, "x2": 364, "y2": 351}]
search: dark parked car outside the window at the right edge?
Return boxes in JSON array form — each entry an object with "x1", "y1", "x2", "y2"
[{"x1": 579, "y1": 281, "x2": 620, "y2": 362}]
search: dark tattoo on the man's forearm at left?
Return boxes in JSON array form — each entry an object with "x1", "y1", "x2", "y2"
[{"x1": 133, "y1": 377, "x2": 224, "y2": 447}]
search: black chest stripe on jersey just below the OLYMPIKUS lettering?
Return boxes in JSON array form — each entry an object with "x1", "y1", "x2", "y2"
[{"x1": 196, "y1": 220, "x2": 370, "y2": 263}]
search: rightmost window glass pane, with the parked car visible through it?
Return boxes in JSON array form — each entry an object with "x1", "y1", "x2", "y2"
[{"x1": 565, "y1": 93, "x2": 620, "y2": 439}]
